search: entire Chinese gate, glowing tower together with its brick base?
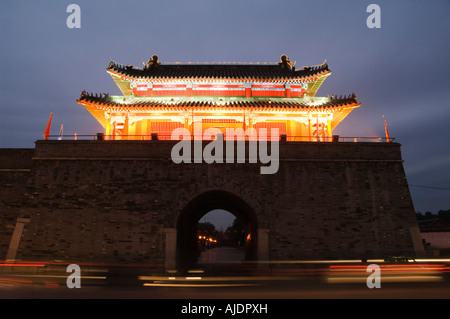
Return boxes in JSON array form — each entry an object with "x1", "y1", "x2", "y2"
[{"x1": 0, "y1": 56, "x2": 423, "y2": 268}]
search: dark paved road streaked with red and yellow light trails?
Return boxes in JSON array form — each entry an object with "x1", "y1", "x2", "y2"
[{"x1": 0, "y1": 255, "x2": 450, "y2": 300}]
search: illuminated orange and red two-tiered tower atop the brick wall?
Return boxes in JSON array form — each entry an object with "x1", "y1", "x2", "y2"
[{"x1": 77, "y1": 55, "x2": 360, "y2": 141}]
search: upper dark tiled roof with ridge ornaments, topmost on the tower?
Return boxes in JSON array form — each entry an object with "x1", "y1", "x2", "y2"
[{"x1": 107, "y1": 55, "x2": 330, "y2": 80}]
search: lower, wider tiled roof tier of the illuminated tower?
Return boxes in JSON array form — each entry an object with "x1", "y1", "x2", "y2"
[{"x1": 77, "y1": 92, "x2": 360, "y2": 111}]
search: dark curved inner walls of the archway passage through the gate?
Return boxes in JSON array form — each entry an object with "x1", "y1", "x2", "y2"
[{"x1": 177, "y1": 191, "x2": 257, "y2": 270}]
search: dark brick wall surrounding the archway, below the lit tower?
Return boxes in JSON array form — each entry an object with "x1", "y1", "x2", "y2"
[{"x1": 0, "y1": 141, "x2": 417, "y2": 265}]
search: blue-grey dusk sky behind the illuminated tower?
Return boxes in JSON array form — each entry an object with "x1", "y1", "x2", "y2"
[{"x1": 0, "y1": 0, "x2": 450, "y2": 220}]
